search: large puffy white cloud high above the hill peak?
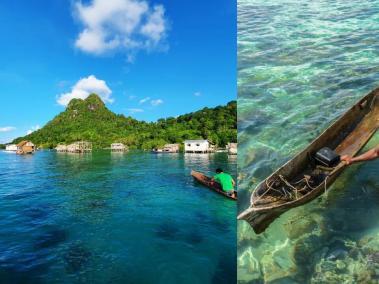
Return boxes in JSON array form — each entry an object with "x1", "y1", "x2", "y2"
[{"x1": 75, "y1": 0, "x2": 167, "y2": 56}]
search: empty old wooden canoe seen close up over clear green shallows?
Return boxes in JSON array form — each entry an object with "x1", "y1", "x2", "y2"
[{"x1": 238, "y1": 88, "x2": 379, "y2": 234}]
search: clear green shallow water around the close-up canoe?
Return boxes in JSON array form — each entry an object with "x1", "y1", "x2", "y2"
[{"x1": 237, "y1": 0, "x2": 379, "y2": 283}]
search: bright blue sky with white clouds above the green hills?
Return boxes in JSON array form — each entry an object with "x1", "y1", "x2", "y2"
[{"x1": 0, "y1": 0, "x2": 236, "y2": 143}]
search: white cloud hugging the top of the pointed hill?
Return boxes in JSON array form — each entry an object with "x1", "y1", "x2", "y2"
[{"x1": 57, "y1": 75, "x2": 114, "y2": 106}]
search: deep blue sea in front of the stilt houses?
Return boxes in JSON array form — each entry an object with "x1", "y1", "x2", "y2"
[{"x1": 0, "y1": 151, "x2": 236, "y2": 283}]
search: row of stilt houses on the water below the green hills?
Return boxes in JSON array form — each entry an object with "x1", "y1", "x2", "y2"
[{"x1": 5, "y1": 139, "x2": 237, "y2": 155}]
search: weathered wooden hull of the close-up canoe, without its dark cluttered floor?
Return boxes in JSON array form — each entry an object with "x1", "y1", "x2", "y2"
[{"x1": 238, "y1": 88, "x2": 379, "y2": 234}]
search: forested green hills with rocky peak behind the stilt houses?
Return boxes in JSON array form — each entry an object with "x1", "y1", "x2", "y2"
[{"x1": 12, "y1": 94, "x2": 237, "y2": 149}]
